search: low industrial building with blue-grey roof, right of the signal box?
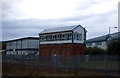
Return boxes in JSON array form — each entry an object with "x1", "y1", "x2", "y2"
[{"x1": 86, "y1": 32, "x2": 120, "y2": 50}]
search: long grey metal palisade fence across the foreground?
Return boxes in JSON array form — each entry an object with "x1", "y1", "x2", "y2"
[{"x1": 2, "y1": 55, "x2": 120, "y2": 75}]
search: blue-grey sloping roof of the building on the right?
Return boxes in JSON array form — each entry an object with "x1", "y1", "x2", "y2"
[{"x1": 86, "y1": 32, "x2": 120, "y2": 43}]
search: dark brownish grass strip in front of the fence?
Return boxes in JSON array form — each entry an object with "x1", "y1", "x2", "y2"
[{"x1": 3, "y1": 65, "x2": 104, "y2": 77}]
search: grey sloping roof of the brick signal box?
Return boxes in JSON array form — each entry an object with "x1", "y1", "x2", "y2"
[{"x1": 39, "y1": 25, "x2": 85, "y2": 34}]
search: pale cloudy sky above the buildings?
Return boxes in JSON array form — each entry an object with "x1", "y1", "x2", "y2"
[{"x1": 1, "y1": 0, "x2": 119, "y2": 41}]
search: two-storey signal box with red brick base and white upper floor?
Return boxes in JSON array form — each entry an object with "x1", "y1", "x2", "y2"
[{"x1": 39, "y1": 25, "x2": 87, "y2": 56}]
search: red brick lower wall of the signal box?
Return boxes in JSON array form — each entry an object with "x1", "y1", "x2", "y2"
[{"x1": 40, "y1": 44, "x2": 84, "y2": 56}]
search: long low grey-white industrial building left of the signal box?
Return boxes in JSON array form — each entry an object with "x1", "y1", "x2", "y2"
[{"x1": 6, "y1": 37, "x2": 39, "y2": 55}]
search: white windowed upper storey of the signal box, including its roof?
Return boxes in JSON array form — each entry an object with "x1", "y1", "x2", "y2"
[{"x1": 39, "y1": 25, "x2": 87, "y2": 44}]
